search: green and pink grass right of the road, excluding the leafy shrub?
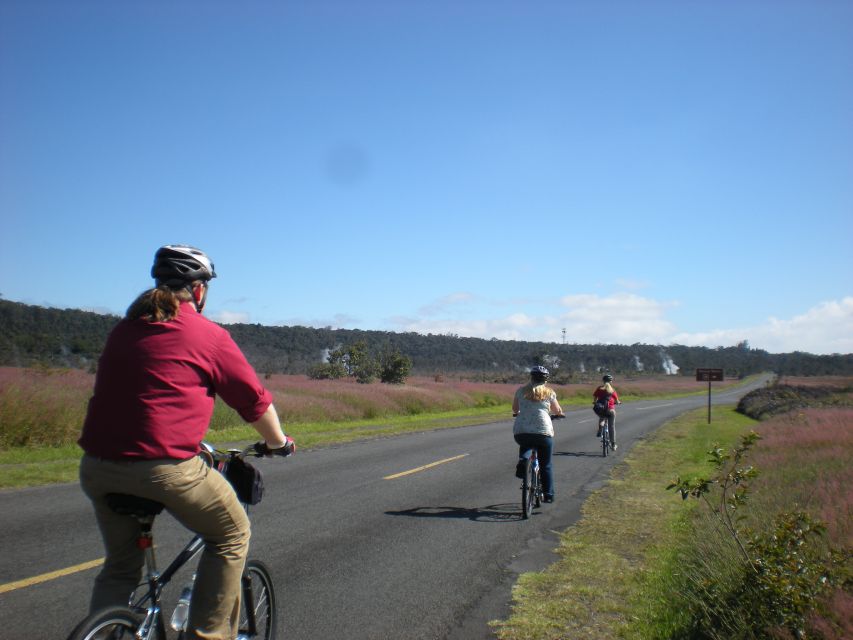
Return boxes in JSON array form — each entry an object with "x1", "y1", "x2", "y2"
[{"x1": 492, "y1": 378, "x2": 853, "y2": 640}]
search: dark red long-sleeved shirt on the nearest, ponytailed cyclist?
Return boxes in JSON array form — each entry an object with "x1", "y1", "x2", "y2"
[{"x1": 78, "y1": 302, "x2": 272, "y2": 460}]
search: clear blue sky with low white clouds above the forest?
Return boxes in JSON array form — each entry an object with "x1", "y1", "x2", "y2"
[{"x1": 0, "y1": 0, "x2": 853, "y2": 353}]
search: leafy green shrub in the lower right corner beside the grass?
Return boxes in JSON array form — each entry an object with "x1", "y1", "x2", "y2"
[{"x1": 667, "y1": 432, "x2": 845, "y2": 639}]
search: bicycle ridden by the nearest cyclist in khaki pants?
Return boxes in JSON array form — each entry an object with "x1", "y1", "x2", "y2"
[{"x1": 68, "y1": 442, "x2": 284, "y2": 640}]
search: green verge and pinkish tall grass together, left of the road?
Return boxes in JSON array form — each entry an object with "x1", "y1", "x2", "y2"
[{"x1": 0, "y1": 368, "x2": 748, "y2": 488}]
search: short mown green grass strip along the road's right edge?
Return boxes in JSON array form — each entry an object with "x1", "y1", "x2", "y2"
[{"x1": 492, "y1": 408, "x2": 754, "y2": 640}]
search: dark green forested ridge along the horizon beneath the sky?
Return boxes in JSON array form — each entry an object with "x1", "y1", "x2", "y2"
[{"x1": 0, "y1": 299, "x2": 853, "y2": 382}]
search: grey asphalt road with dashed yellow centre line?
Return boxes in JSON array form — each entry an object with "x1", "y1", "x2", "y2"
[{"x1": 0, "y1": 383, "x2": 764, "y2": 640}]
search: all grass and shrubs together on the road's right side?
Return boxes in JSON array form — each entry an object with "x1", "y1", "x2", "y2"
[{"x1": 492, "y1": 378, "x2": 853, "y2": 640}]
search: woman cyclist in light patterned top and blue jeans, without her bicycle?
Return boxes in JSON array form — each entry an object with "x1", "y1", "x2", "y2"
[{"x1": 512, "y1": 367, "x2": 563, "y2": 502}]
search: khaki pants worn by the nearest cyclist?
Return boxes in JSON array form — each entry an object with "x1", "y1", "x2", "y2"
[{"x1": 80, "y1": 455, "x2": 249, "y2": 640}]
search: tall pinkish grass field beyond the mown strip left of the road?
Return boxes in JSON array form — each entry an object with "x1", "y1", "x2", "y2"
[{"x1": 0, "y1": 367, "x2": 736, "y2": 448}]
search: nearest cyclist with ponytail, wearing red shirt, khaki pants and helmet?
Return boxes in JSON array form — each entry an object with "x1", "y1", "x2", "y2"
[{"x1": 79, "y1": 245, "x2": 295, "y2": 640}]
